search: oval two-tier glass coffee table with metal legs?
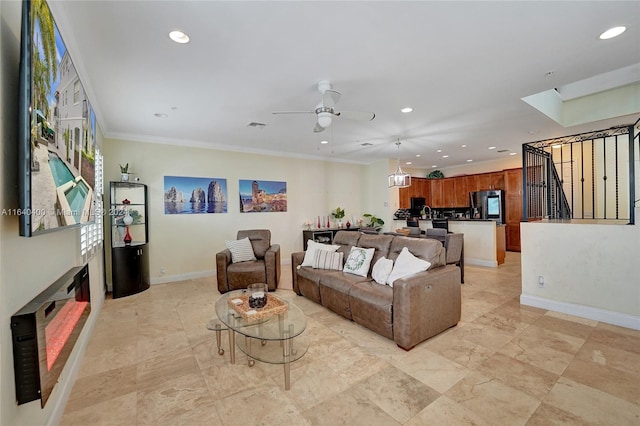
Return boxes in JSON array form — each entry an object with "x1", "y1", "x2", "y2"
[{"x1": 215, "y1": 290, "x2": 309, "y2": 390}]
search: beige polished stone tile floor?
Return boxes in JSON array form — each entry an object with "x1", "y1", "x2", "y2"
[{"x1": 61, "y1": 253, "x2": 640, "y2": 426}]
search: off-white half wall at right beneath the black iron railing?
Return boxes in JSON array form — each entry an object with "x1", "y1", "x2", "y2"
[{"x1": 520, "y1": 220, "x2": 640, "y2": 329}]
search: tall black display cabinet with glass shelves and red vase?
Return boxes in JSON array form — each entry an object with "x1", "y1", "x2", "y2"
[{"x1": 109, "y1": 182, "x2": 150, "y2": 299}]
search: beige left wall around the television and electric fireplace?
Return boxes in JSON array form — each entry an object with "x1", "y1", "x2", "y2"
[{"x1": 0, "y1": 1, "x2": 104, "y2": 425}]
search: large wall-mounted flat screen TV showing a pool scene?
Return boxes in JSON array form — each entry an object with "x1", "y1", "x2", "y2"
[{"x1": 17, "y1": 0, "x2": 96, "y2": 237}]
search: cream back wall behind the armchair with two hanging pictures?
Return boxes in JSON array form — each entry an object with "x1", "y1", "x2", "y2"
[{"x1": 104, "y1": 140, "x2": 393, "y2": 283}]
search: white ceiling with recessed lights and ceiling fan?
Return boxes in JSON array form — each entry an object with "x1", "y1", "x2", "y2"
[{"x1": 51, "y1": 0, "x2": 640, "y2": 168}]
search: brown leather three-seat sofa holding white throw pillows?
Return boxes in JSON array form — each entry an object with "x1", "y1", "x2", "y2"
[{"x1": 291, "y1": 231, "x2": 461, "y2": 350}]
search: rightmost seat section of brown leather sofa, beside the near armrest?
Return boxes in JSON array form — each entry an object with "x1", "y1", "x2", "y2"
[{"x1": 349, "y1": 281, "x2": 393, "y2": 339}]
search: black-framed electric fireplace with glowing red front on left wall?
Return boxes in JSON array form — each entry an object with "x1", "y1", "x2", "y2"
[{"x1": 11, "y1": 265, "x2": 91, "y2": 407}]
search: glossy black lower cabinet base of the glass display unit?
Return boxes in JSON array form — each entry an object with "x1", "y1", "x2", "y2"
[{"x1": 111, "y1": 244, "x2": 150, "y2": 299}]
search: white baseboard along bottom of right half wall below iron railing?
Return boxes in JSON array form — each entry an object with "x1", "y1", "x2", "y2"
[{"x1": 520, "y1": 294, "x2": 640, "y2": 330}]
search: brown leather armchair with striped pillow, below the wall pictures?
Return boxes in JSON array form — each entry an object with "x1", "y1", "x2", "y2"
[{"x1": 216, "y1": 229, "x2": 280, "y2": 293}]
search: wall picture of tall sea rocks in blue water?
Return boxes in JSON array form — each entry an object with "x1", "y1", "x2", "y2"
[{"x1": 164, "y1": 176, "x2": 227, "y2": 214}]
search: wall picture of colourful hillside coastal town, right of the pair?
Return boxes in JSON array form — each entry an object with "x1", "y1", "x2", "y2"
[{"x1": 239, "y1": 179, "x2": 287, "y2": 213}]
